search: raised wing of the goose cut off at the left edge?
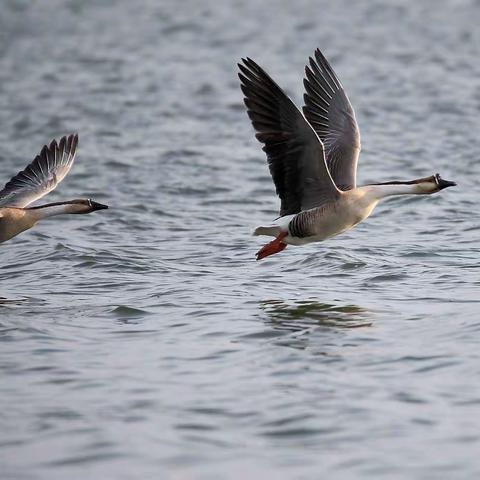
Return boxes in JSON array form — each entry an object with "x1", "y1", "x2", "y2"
[{"x1": 0, "y1": 135, "x2": 78, "y2": 208}]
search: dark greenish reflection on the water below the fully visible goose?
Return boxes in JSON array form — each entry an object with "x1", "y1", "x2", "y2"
[{"x1": 260, "y1": 300, "x2": 372, "y2": 332}]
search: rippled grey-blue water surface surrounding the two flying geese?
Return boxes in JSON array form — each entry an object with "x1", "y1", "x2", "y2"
[{"x1": 0, "y1": 0, "x2": 480, "y2": 480}]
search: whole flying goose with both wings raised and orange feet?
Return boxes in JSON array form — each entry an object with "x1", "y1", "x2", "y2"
[{"x1": 238, "y1": 49, "x2": 456, "y2": 260}]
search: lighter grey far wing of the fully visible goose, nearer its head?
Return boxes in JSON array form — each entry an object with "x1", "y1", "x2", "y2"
[{"x1": 303, "y1": 49, "x2": 360, "y2": 190}]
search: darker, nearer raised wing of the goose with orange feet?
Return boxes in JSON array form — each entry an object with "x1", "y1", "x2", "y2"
[{"x1": 238, "y1": 58, "x2": 340, "y2": 216}]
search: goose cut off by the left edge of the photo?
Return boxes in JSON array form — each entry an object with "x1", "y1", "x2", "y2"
[{"x1": 0, "y1": 134, "x2": 108, "y2": 243}]
